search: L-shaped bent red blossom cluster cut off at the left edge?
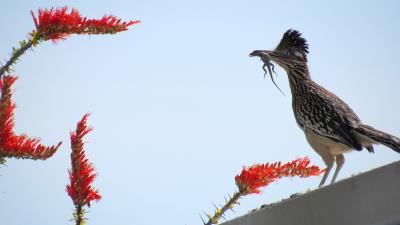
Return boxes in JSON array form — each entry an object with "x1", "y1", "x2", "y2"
[{"x1": 0, "y1": 76, "x2": 61, "y2": 159}]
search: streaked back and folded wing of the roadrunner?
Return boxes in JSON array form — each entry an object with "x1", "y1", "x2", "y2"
[{"x1": 289, "y1": 71, "x2": 362, "y2": 150}]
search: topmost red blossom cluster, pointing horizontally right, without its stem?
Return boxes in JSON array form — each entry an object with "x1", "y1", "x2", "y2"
[{"x1": 31, "y1": 6, "x2": 140, "y2": 41}]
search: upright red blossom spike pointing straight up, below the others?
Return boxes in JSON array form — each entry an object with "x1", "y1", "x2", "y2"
[{"x1": 67, "y1": 114, "x2": 101, "y2": 207}]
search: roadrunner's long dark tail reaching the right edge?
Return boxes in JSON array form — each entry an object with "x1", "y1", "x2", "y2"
[{"x1": 356, "y1": 124, "x2": 400, "y2": 153}]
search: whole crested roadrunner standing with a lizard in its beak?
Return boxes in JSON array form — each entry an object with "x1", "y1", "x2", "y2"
[{"x1": 250, "y1": 30, "x2": 400, "y2": 186}]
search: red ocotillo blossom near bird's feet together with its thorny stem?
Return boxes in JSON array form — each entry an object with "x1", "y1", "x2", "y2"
[{"x1": 202, "y1": 157, "x2": 324, "y2": 225}]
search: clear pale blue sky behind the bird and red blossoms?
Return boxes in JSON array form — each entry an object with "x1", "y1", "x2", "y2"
[{"x1": 0, "y1": 0, "x2": 400, "y2": 225}]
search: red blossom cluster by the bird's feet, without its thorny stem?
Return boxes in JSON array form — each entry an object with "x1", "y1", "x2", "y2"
[{"x1": 235, "y1": 157, "x2": 324, "y2": 195}]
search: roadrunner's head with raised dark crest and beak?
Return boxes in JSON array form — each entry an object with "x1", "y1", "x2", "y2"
[{"x1": 250, "y1": 29, "x2": 308, "y2": 70}]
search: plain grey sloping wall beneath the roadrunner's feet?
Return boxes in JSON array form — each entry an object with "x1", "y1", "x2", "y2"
[{"x1": 223, "y1": 161, "x2": 400, "y2": 225}]
